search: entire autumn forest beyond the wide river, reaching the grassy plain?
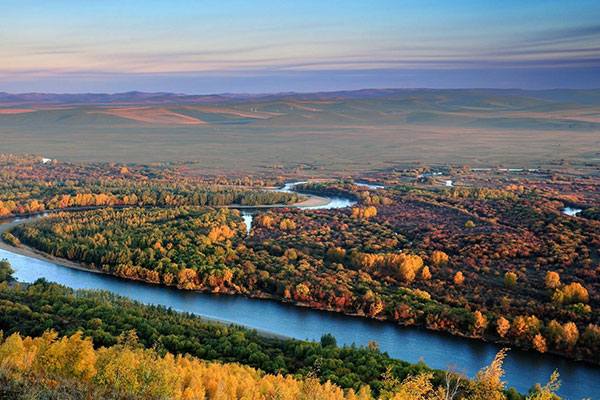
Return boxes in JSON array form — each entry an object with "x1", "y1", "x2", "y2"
[{"x1": 0, "y1": 156, "x2": 600, "y2": 363}]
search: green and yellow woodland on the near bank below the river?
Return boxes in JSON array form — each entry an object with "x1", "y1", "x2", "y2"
[{"x1": 0, "y1": 262, "x2": 558, "y2": 400}]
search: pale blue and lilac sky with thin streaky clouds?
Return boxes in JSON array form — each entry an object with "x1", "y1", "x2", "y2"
[{"x1": 0, "y1": 0, "x2": 600, "y2": 94}]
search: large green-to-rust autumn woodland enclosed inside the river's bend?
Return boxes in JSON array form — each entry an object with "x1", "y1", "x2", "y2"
[{"x1": 9, "y1": 183, "x2": 600, "y2": 362}]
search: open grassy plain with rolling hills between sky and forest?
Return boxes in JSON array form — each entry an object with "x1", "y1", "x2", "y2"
[{"x1": 0, "y1": 90, "x2": 600, "y2": 175}]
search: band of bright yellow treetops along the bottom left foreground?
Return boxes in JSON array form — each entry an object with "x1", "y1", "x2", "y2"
[{"x1": 0, "y1": 332, "x2": 360, "y2": 400}]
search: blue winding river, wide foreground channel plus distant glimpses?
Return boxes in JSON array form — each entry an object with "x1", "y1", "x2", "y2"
[{"x1": 0, "y1": 184, "x2": 600, "y2": 400}]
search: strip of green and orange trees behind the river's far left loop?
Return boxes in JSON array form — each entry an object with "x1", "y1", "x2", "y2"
[{"x1": 0, "y1": 154, "x2": 303, "y2": 217}]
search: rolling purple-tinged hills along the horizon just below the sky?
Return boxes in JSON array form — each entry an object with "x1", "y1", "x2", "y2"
[{"x1": 0, "y1": 89, "x2": 600, "y2": 130}]
